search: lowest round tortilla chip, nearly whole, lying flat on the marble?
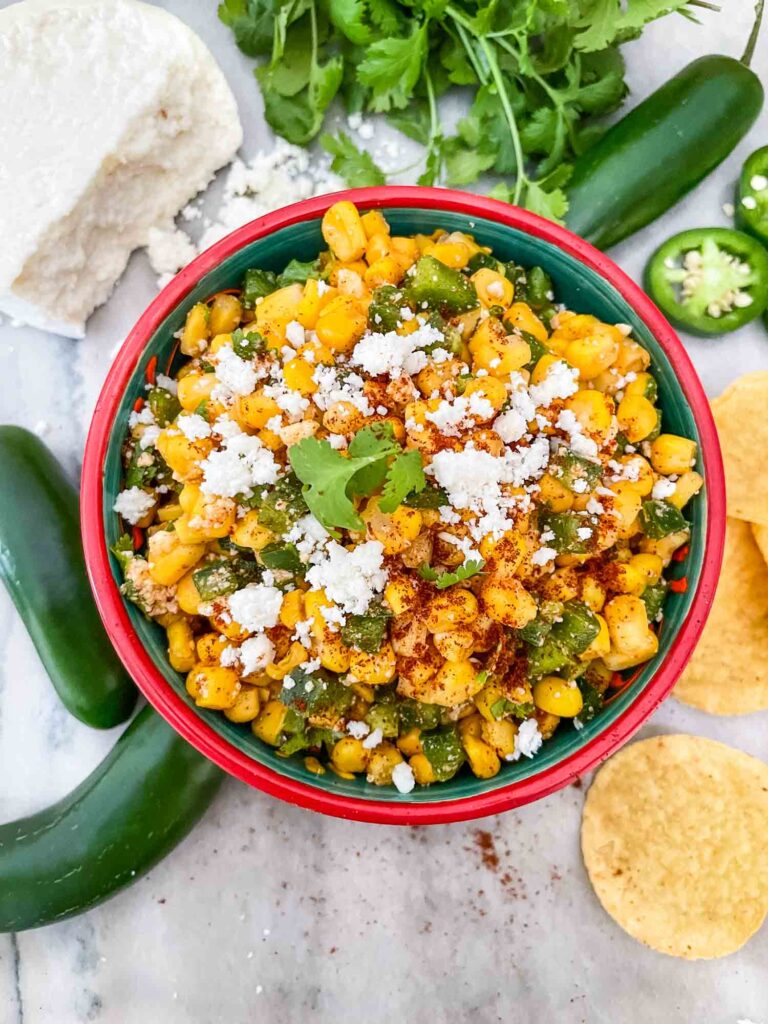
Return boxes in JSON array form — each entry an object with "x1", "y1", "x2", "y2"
[{"x1": 582, "y1": 735, "x2": 768, "y2": 959}]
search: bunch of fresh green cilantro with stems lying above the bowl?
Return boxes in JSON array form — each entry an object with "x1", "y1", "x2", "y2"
[{"x1": 219, "y1": 0, "x2": 712, "y2": 220}]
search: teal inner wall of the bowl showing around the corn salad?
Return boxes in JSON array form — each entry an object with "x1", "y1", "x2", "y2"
[{"x1": 103, "y1": 208, "x2": 707, "y2": 804}]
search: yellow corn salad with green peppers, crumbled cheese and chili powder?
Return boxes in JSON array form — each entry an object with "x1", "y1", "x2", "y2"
[{"x1": 114, "y1": 202, "x2": 703, "y2": 794}]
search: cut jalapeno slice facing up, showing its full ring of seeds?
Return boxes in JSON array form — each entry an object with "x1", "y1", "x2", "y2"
[{"x1": 646, "y1": 227, "x2": 768, "y2": 335}]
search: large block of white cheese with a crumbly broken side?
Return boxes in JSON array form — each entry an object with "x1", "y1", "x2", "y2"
[{"x1": 0, "y1": 0, "x2": 243, "y2": 338}]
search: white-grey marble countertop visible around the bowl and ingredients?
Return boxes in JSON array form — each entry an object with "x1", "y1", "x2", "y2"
[{"x1": 0, "y1": 0, "x2": 768, "y2": 1024}]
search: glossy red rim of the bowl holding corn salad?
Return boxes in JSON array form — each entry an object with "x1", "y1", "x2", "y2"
[{"x1": 81, "y1": 185, "x2": 725, "y2": 825}]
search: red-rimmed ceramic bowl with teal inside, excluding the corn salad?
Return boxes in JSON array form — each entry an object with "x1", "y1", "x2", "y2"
[{"x1": 82, "y1": 186, "x2": 725, "y2": 824}]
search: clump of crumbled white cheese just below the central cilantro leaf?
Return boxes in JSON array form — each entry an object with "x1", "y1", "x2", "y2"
[{"x1": 306, "y1": 541, "x2": 387, "y2": 618}]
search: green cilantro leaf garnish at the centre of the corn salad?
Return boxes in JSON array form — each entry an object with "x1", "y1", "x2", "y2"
[{"x1": 289, "y1": 423, "x2": 427, "y2": 530}]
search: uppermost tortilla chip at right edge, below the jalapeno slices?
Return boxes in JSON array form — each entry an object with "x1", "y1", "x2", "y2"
[{"x1": 712, "y1": 370, "x2": 768, "y2": 526}]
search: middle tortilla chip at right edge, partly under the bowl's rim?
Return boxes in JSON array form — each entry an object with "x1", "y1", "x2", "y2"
[{"x1": 673, "y1": 518, "x2": 768, "y2": 715}]
